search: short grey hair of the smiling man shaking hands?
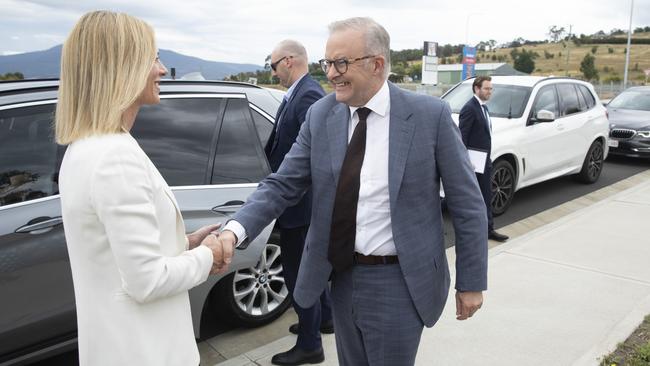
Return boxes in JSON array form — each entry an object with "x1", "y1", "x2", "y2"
[{"x1": 328, "y1": 17, "x2": 390, "y2": 78}]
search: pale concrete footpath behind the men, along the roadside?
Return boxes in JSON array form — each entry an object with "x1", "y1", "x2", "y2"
[{"x1": 205, "y1": 171, "x2": 650, "y2": 366}]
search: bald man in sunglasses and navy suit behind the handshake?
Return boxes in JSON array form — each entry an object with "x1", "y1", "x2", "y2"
[{"x1": 264, "y1": 40, "x2": 334, "y2": 365}]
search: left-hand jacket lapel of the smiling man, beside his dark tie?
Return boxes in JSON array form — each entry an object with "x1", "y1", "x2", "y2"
[{"x1": 325, "y1": 103, "x2": 350, "y2": 184}]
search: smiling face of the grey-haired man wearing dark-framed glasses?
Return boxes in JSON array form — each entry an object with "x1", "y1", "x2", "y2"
[{"x1": 325, "y1": 30, "x2": 383, "y2": 107}]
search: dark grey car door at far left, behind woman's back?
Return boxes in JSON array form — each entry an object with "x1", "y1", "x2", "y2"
[{"x1": 0, "y1": 100, "x2": 77, "y2": 362}]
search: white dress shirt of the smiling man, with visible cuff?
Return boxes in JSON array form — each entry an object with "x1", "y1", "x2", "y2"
[{"x1": 224, "y1": 82, "x2": 397, "y2": 255}]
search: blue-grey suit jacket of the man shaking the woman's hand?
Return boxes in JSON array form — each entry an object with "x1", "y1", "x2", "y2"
[{"x1": 234, "y1": 83, "x2": 487, "y2": 326}]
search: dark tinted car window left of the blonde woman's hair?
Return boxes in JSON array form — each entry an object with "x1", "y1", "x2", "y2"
[{"x1": 0, "y1": 104, "x2": 59, "y2": 206}]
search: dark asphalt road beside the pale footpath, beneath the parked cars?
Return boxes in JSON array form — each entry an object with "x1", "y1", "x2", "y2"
[{"x1": 26, "y1": 156, "x2": 650, "y2": 366}]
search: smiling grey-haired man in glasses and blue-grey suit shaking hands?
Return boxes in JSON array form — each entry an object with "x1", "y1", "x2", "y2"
[{"x1": 216, "y1": 18, "x2": 487, "y2": 366}]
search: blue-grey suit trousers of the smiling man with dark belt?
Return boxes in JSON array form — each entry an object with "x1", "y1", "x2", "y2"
[{"x1": 332, "y1": 264, "x2": 424, "y2": 366}]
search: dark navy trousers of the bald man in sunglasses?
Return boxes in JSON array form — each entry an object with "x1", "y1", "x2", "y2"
[{"x1": 280, "y1": 226, "x2": 332, "y2": 350}]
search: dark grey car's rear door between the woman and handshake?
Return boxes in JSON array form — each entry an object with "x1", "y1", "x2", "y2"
[{"x1": 132, "y1": 93, "x2": 271, "y2": 336}]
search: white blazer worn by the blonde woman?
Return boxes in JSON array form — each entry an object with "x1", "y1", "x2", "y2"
[{"x1": 59, "y1": 133, "x2": 212, "y2": 366}]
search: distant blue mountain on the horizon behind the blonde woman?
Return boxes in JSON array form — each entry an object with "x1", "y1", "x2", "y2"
[{"x1": 0, "y1": 45, "x2": 263, "y2": 80}]
